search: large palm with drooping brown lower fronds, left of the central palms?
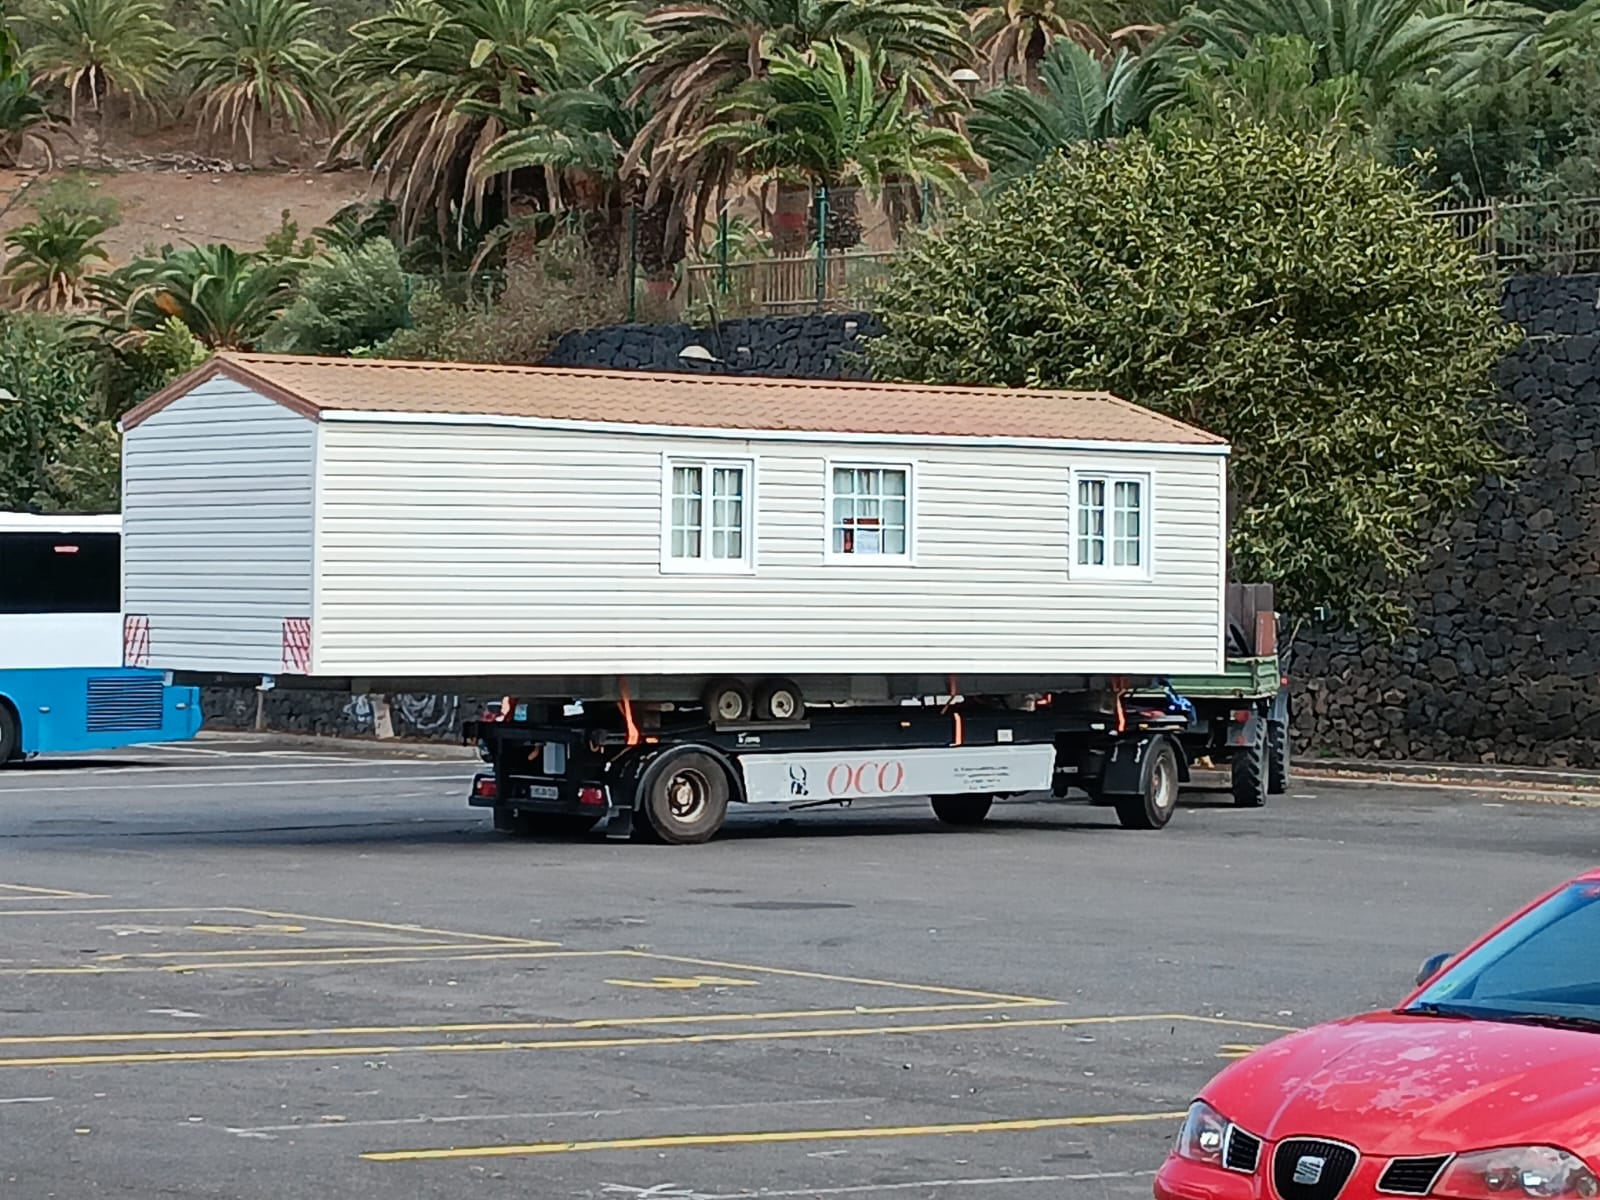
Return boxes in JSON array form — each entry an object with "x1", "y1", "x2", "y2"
[{"x1": 334, "y1": 0, "x2": 592, "y2": 237}]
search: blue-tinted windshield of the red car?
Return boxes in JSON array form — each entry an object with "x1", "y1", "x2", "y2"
[{"x1": 1400, "y1": 882, "x2": 1600, "y2": 1030}]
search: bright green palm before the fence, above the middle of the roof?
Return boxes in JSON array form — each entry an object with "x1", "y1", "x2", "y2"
[{"x1": 699, "y1": 42, "x2": 978, "y2": 250}]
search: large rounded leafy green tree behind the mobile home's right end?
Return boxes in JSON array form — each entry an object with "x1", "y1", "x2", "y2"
[{"x1": 869, "y1": 125, "x2": 1509, "y2": 624}]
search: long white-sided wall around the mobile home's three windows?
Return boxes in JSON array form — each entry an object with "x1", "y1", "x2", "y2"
[{"x1": 302, "y1": 425, "x2": 1224, "y2": 677}]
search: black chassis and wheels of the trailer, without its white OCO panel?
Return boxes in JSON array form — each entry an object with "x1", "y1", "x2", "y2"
[{"x1": 462, "y1": 694, "x2": 1189, "y2": 843}]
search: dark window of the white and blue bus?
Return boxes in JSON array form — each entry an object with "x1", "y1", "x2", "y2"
[{"x1": 0, "y1": 533, "x2": 122, "y2": 613}]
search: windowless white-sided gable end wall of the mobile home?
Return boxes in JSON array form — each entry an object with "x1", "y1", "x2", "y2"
[{"x1": 122, "y1": 378, "x2": 317, "y2": 674}]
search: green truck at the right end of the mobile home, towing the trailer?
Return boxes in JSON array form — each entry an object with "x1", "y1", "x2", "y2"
[{"x1": 1138, "y1": 584, "x2": 1290, "y2": 808}]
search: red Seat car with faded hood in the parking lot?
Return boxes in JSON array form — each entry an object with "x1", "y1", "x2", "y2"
[{"x1": 1155, "y1": 870, "x2": 1600, "y2": 1200}]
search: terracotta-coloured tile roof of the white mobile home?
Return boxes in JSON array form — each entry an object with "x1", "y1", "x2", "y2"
[{"x1": 123, "y1": 354, "x2": 1224, "y2": 446}]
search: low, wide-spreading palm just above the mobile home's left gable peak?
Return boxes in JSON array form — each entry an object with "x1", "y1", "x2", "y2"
[{"x1": 86, "y1": 245, "x2": 306, "y2": 350}]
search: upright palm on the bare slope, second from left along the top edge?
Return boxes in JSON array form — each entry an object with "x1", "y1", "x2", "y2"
[{"x1": 178, "y1": 0, "x2": 331, "y2": 162}]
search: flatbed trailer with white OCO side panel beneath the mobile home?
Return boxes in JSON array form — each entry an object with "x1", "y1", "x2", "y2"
[{"x1": 464, "y1": 694, "x2": 1189, "y2": 843}]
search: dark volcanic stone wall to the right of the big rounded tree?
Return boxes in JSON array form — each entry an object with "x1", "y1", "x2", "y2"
[{"x1": 1290, "y1": 275, "x2": 1600, "y2": 766}]
